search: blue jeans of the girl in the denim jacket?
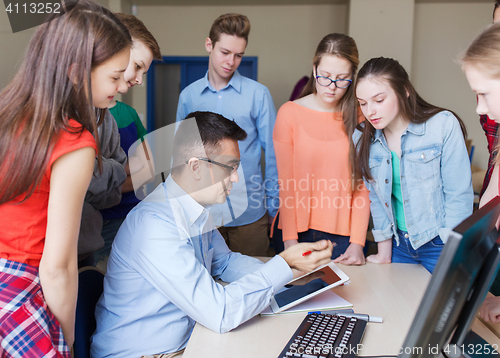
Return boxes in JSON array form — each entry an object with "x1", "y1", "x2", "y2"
[{"x1": 392, "y1": 229, "x2": 444, "y2": 273}]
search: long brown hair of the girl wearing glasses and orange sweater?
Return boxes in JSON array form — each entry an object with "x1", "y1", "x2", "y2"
[{"x1": 299, "y1": 33, "x2": 359, "y2": 180}]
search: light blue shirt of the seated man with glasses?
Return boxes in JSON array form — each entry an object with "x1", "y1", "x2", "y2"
[{"x1": 91, "y1": 176, "x2": 293, "y2": 358}]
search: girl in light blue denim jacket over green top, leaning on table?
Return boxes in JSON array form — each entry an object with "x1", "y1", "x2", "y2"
[{"x1": 354, "y1": 57, "x2": 474, "y2": 272}]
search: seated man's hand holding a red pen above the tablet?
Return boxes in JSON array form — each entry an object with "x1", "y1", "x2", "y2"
[{"x1": 279, "y1": 240, "x2": 333, "y2": 272}]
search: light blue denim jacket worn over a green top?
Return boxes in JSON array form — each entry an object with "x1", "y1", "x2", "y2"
[{"x1": 353, "y1": 111, "x2": 474, "y2": 249}]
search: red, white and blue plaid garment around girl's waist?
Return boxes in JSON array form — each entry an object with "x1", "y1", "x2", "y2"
[{"x1": 0, "y1": 258, "x2": 71, "y2": 358}]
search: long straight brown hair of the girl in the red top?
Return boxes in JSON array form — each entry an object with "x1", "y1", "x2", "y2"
[{"x1": 0, "y1": 0, "x2": 132, "y2": 204}]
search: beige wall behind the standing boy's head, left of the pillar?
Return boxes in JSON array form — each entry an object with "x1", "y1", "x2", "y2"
[{"x1": 132, "y1": 4, "x2": 347, "y2": 119}]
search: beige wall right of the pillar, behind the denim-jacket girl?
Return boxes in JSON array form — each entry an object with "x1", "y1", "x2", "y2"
[{"x1": 411, "y1": 1, "x2": 493, "y2": 169}]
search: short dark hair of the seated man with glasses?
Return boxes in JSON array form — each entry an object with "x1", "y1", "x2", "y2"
[{"x1": 172, "y1": 112, "x2": 247, "y2": 171}]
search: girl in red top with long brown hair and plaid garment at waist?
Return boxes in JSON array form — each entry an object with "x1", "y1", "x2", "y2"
[{"x1": 0, "y1": 0, "x2": 131, "y2": 357}]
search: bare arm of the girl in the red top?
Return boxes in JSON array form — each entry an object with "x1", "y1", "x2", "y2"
[{"x1": 39, "y1": 147, "x2": 95, "y2": 347}]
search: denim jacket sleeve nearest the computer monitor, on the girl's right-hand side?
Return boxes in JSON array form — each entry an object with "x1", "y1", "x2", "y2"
[{"x1": 439, "y1": 114, "x2": 474, "y2": 242}]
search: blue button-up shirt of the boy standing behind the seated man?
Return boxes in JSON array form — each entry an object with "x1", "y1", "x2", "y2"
[{"x1": 177, "y1": 71, "x2": 279, "y2": 226}]
